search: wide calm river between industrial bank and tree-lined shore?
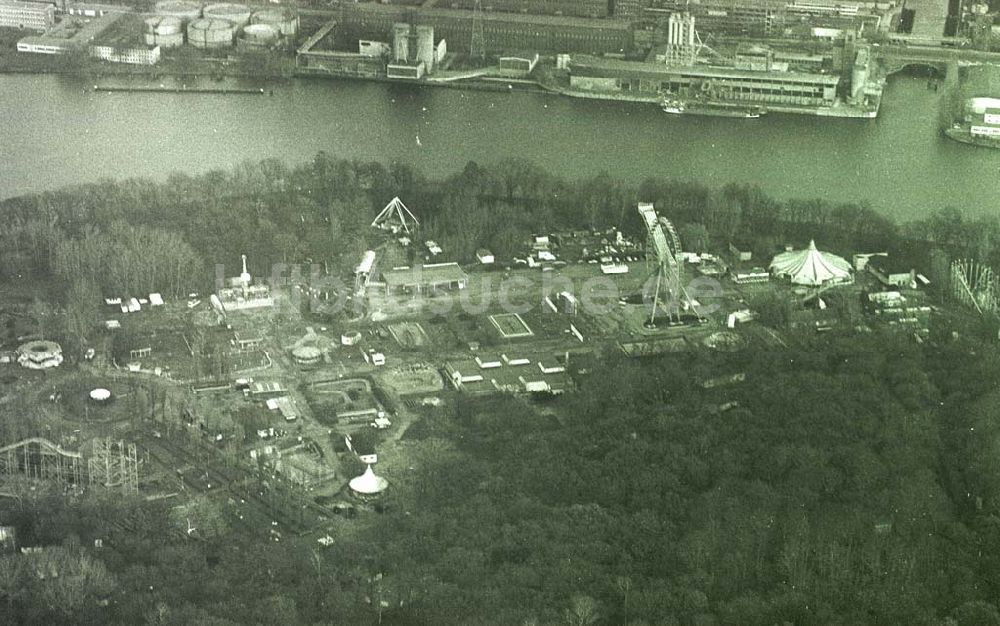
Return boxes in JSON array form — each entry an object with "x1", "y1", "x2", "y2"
[{"x1": 0, "y1": 75, "x2": 1000, "y2": 219}]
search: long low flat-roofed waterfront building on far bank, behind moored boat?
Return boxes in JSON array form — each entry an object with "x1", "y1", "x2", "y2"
[{"x1": 570, "y1": 57, "x2": 840, "y2": 107}]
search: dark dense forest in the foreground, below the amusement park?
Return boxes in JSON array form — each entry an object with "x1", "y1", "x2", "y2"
[{"x1": 0, "y1": 328, "x2": 1000, "y2": 626}]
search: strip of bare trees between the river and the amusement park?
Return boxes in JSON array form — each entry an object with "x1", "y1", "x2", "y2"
[{"x1": 0, "y1": 153, "x2": 1000, "y2": 304}]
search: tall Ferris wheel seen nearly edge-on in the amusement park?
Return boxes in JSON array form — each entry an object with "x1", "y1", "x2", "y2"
[{"x1": 638, "y1": 202, "x2": 701, "y2": 327}]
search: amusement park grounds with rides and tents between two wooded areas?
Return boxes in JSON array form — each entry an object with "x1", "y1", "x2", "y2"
[{"x1": 0, "y1": 191, "x2": 948, "y2": 541}]
